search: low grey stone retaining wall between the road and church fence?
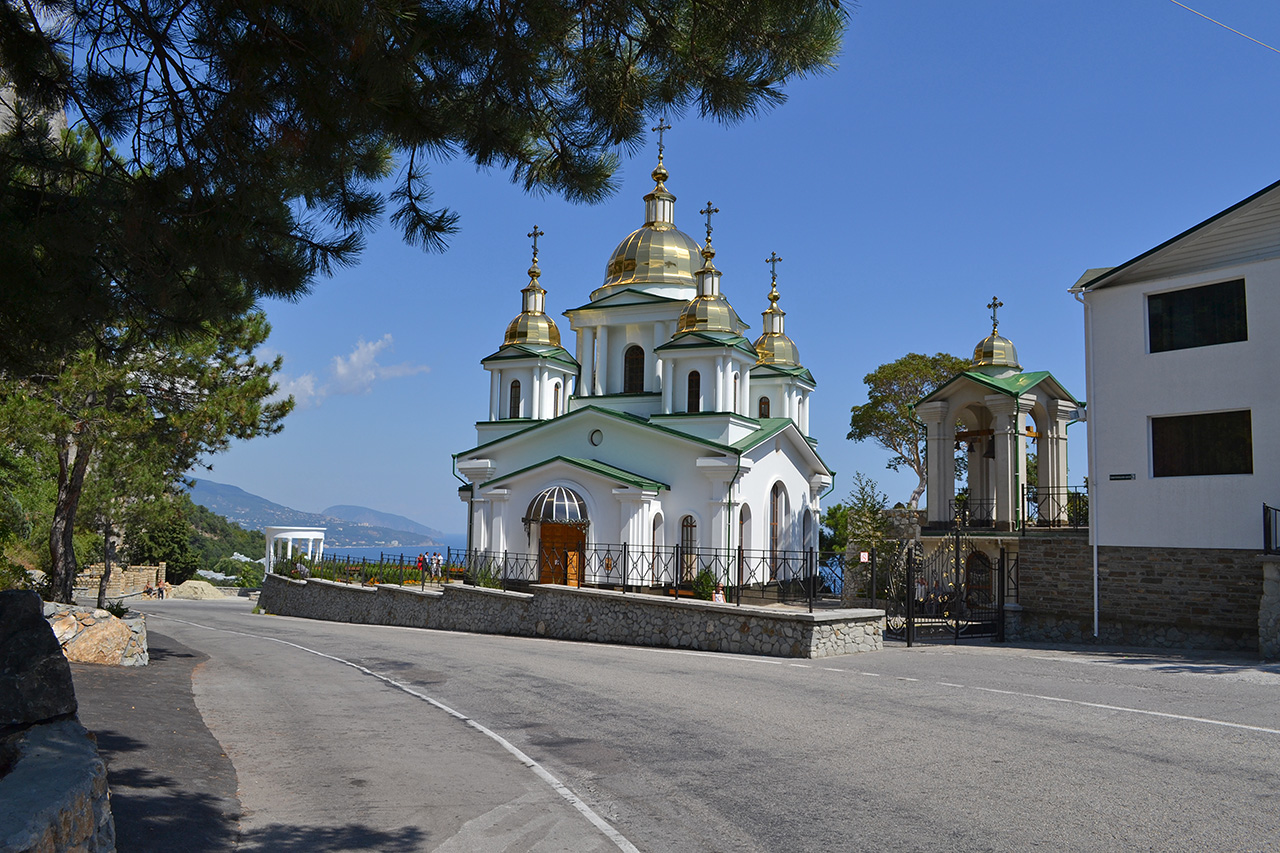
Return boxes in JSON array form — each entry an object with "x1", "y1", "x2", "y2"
[{"x1": 259, "y1": 575, "x2": 884, "y2": 657}]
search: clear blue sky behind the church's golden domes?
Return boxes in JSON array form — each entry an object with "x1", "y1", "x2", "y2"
[{"x1": 195, "y1": 0, "x2": 1280, "y2": 533}]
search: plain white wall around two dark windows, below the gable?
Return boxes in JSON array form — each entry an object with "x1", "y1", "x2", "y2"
[{"x1": 1084, "y1": 253, "x2": 1280, "y2": 548}]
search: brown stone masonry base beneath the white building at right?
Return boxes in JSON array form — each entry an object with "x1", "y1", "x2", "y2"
[{"x1": 1006, "y1": 532, "x2": 1262, "y2": 651}]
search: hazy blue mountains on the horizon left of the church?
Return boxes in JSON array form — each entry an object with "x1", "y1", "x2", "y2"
[{"x1": 191, "y1": 480, "x2": 444, "y2": 549}]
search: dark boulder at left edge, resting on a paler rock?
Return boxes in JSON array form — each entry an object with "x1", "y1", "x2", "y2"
[{"x1": 0, "y1": 590, "x2": 76, "y2": 726}]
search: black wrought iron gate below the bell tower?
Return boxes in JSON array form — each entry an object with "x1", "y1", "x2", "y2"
[{"x1": 884, "y1": 530, "x2": 1007, "y2": 646}]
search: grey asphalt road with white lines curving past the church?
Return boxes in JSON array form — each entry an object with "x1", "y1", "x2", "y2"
[{"x1": 72, "y1": 599, "x2": 1280, "y2": 850}]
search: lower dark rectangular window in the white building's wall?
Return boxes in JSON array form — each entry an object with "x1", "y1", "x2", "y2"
[{"x1": 1151, "y1": 409, "x2": 1253, "y2": 476}]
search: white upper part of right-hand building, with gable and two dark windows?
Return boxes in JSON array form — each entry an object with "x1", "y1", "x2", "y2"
[{"x1": 1071, "y1": 183, "x2": 1280, "y2": 553}]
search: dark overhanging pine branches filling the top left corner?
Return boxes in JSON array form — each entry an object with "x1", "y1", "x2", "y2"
[{"x1": 0, "y1": 0, "x2": 846, "y2": 371}]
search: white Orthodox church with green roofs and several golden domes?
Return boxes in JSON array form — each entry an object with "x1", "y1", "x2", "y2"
[{"x1": 454, "y1": 147, "x2": 832, "y2": 585}]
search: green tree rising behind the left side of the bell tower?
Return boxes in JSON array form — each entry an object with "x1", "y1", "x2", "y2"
[{"x1": 846, "y1": 352, "x2": 969, "y2": 510}]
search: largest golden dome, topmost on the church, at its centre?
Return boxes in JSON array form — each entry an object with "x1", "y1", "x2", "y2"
[{"x1": 591, "y1": 163, "x2": 701, "y2": 301}]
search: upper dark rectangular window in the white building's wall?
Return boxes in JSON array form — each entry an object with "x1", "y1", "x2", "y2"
[{"x1": 1147, "y1": 278, "x2": 1249, "y2": 352}]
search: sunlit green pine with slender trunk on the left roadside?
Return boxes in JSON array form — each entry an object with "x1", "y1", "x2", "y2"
[{"x1": 0, "y1": 313, "x2": 293, "y2": 602}]
